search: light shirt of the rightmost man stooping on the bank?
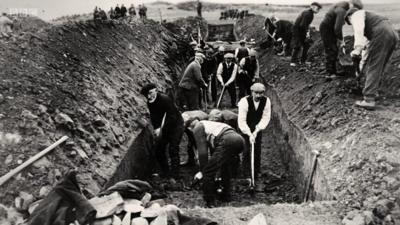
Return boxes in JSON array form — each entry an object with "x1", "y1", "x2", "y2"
[{"x1": 351, "y1": 10, "x2": 368, "y2": 48}]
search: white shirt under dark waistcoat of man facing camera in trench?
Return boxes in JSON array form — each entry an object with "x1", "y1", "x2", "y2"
[{"x1": 238, "y1": 97, "x2": 271, "y2": 135}]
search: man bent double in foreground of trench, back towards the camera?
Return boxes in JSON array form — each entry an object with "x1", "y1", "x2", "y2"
[{"x1": 190, "y1": 119, "x2": 244, "y2": 207}]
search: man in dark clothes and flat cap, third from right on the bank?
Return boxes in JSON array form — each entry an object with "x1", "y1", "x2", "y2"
[{"x1": 290, "y1": 2, "x2": 322, "y2": 66}]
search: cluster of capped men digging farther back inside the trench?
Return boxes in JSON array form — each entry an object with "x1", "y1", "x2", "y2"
[{"x1": 179, "y1": 40, "x2": 260, "y2": 110}]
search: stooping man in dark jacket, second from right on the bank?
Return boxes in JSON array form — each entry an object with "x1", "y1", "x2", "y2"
[{"x1": 319, "y1": 2, "x2": 350, "y2": 75}]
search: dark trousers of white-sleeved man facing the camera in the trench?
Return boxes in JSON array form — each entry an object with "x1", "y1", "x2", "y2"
[{"x1": 243, "y1": 131, "x2": 262, "y2": 177}]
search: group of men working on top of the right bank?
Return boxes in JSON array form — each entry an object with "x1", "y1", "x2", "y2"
[{"x1": 264, "y1": 0, "x2": 399, "y2": 109}]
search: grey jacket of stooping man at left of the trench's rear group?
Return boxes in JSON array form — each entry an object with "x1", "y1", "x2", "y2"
[{"x1": 179, "y1": 60, "x2": 205, "y2": 91}]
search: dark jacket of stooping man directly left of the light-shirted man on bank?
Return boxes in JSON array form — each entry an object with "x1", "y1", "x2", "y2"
[{"x1": 320, "y1": 2, "x2": 350, "y2": 40}]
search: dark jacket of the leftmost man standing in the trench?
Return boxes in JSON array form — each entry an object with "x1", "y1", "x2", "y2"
[{"x1": 147, "y1": 93, "x2": 183, "y2": 134}]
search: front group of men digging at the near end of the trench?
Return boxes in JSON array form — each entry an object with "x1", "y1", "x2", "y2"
[{"x1": 141, "y1": 83, "x2": 271, "y2": 207}]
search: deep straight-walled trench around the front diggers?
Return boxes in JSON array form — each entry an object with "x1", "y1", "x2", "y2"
[{"x1": 103, "y1": 23, "x2": 333, "y2": 208}]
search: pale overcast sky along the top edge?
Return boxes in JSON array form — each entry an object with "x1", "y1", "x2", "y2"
[{"x1": 0, "y1": 0, "x2": 400, "y2": 20}]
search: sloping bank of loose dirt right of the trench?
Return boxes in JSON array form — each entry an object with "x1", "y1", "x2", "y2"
[{"x1": 236, "y1": 15, "x2": 400, "y2": 218}]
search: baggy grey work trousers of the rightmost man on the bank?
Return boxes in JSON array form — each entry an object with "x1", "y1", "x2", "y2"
[{"x1": 363, "y1": 20, "x2": 399, "y2": 101}]
